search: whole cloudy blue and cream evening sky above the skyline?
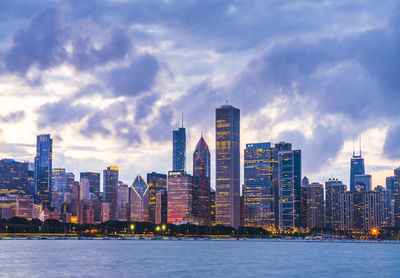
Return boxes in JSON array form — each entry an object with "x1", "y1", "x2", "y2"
[{"x1": 0, "y1": 0, "x2": 400, "y2": 189}]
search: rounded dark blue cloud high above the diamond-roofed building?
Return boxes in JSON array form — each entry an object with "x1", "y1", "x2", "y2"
[{"x1": 107, "y1": 54, "x2": 160, "y2": 96}]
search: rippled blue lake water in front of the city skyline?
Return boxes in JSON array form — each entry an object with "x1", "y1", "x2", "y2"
[{"x1": 0, "y1": 240, "x2": 400, "y2": 278}]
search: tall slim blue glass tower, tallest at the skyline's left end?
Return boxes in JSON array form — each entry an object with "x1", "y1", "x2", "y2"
[{"x1": 34, "y1": 134, "x2": 53, "y2": 207}]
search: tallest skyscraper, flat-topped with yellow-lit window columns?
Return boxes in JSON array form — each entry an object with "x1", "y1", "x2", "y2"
[{"x1": 215, "y1": 105, "x2": 240, "y2": 227}]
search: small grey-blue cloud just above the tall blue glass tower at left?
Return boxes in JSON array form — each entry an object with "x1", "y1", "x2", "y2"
[{"x1": 36, "y1": 99, "x2": 91, "y2": 128}]
